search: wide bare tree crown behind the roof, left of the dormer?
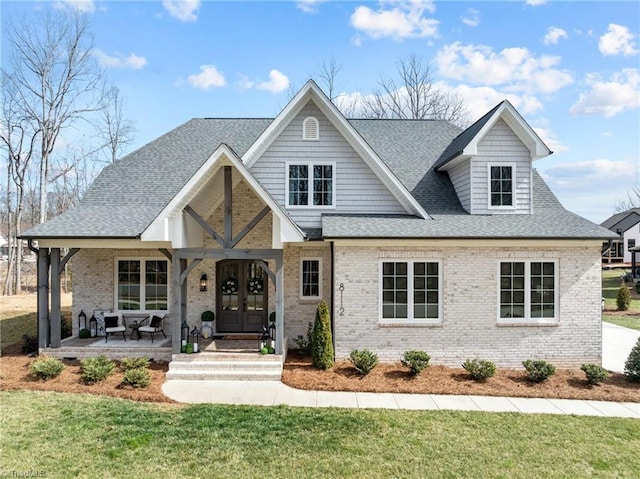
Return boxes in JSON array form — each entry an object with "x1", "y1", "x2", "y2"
[{"x1": 364, "y1": 54, "x2": 467, "y2": 124}]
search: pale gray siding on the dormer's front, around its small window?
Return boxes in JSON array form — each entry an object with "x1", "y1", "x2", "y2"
[{"x1": 470, "y1": 119, "x2": 531, "y2": 215}]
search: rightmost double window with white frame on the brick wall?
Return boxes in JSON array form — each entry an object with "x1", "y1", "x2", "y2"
[{"x1": 499, "y1": 261, "x2": 558, "y2": 322}]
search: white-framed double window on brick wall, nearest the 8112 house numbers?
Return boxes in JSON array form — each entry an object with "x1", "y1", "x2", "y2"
[{"x1": 380, "y1": 261, "x2": 442, "y2": 321}]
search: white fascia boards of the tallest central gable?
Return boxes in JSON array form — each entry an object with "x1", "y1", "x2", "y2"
[{"x1": 242, "y1": 80, "x2": 432, "y2": 219}]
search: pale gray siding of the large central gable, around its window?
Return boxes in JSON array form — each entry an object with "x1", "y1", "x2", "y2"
[{"x1": 250, "y1": 101, "x2": 406, "y2": 228}]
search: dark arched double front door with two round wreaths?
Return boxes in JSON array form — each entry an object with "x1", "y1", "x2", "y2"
[{"x1": 216, "y1": 259, "x2": 268, "y2": 333}]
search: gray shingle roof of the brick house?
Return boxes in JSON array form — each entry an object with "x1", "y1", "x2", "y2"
[{"x1": 23, "y1": 115, "x2": 611, "y2": 242}]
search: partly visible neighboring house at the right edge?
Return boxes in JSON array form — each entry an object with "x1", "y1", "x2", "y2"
[{"x1": 600, "y1": 208, "x2": 640, "y2": 263}]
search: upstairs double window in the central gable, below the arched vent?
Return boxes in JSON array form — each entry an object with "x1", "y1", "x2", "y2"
[{"x1": 287, "y1": 163, "x2": 335, "y2": 207}]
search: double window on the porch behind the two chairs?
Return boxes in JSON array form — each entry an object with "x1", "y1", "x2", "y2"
[{"x1": 116, "y1": 259, "x2": 169, "y2": 311}]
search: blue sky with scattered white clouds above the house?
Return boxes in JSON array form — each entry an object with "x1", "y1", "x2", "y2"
[{"x1": 0, "y1": 0, "x2": 640, "y2": 223}]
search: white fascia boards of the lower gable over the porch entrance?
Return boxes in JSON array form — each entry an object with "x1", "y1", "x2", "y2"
[{"x1": 141, "y1": 144, "x2": 305, "y2": 244}]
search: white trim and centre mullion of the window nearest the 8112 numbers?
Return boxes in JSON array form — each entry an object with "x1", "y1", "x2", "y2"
[{"x1": 378, "y1": 258, "x2": 444, "y2": 326}]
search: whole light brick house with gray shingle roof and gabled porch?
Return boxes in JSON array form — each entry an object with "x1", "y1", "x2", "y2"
[{"x1": 24, "y1": 81, "x2": 611, "y2": 366}]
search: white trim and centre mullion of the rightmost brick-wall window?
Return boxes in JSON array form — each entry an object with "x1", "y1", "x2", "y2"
[{"x1": 496, "y1": 258, "x2": 560, "y2": 325}]
